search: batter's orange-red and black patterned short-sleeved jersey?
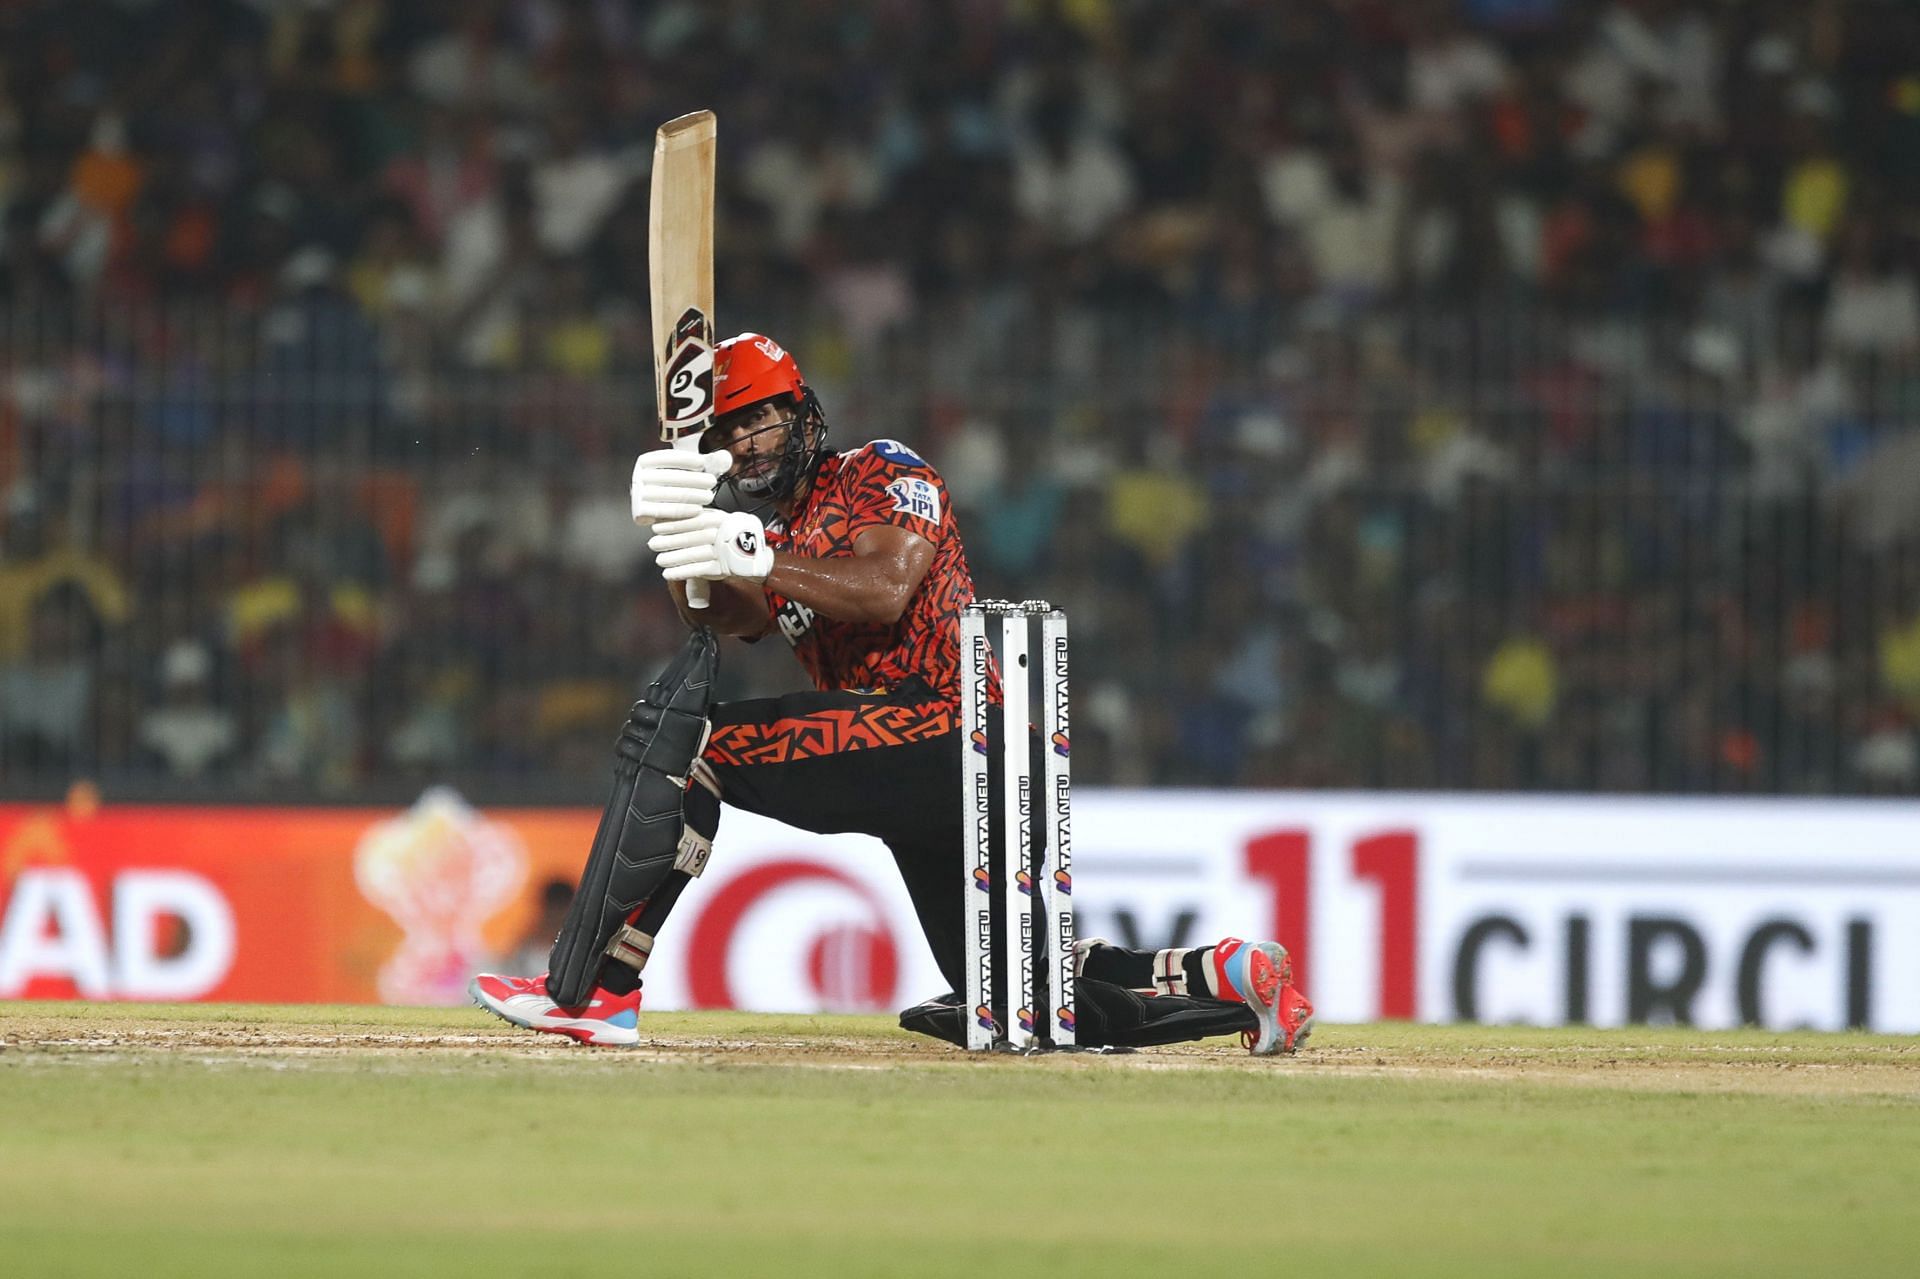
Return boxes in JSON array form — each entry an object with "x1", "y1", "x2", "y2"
[{"x1": 766, "y1": 440, "x2": 996, "y2": 701}]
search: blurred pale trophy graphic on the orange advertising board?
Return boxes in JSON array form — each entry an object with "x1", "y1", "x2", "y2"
[{"x1": 353, "y1": 787, "x2": 526, "y2": 1004}]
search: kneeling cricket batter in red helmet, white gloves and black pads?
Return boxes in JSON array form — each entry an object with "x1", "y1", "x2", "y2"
[{"x1": 468, "y1": 332, "x2": 1313, "y2": 1054}]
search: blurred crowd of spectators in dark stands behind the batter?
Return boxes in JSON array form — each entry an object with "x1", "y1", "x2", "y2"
[{"x1": 0, "y1": 0, "x2": 1920, "y2": 799}]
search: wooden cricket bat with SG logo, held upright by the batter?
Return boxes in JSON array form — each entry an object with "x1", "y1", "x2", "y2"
[{"x1": 647, "y1": 111, "x2": 714, "y2": 609}]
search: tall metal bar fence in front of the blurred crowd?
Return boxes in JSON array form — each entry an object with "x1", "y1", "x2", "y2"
[{"x1": 0, "y1": 292, "x2": 1920, "y2": 801}]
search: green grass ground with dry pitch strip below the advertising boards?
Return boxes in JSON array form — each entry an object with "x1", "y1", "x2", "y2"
[{"x1": 0, "y1": 1002, "x2": 1920, "y2": 1279}]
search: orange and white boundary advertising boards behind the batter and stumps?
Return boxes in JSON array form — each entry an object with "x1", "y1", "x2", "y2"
[{"x1": 0, "y1": 791, "x2": 1920, "y2": 1033}]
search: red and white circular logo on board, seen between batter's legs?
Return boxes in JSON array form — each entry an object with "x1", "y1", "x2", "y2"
[{"x1": 687, "y1": 857, "x2": 900, "y2": 1012}]
